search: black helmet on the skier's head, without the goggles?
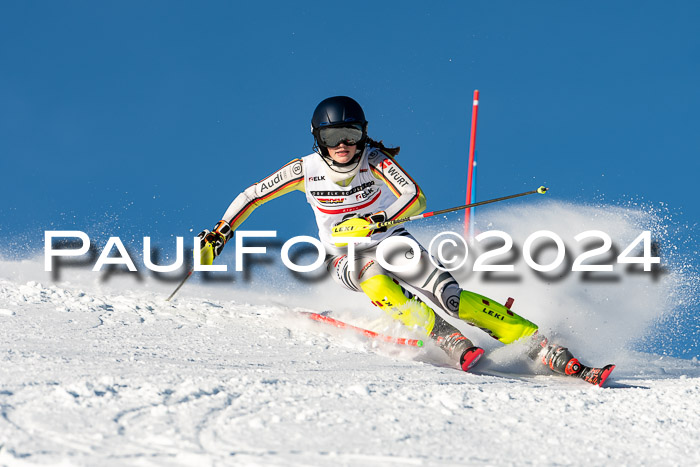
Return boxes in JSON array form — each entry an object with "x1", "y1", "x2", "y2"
[{"x1": 311, "y1": 96, "x2": 367, "y2": 152}]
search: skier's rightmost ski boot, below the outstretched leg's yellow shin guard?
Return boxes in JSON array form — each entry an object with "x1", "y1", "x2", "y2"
[{"x1": 528, "y1": 333, "x2": 615, "y2": 386}]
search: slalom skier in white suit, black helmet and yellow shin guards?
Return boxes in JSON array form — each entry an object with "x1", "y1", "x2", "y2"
[{"x1": 199, "y1": 96, "x2": 614, "y2": 385}]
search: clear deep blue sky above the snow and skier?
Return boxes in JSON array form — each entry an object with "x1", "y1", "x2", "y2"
[{"x1": 0, "y1": 1, "x2": 700, "y2": 253}]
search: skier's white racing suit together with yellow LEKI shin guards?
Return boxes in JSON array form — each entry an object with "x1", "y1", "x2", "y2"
[{"x1": 215, "y1": 146, "x2": 537, "y2": 344}]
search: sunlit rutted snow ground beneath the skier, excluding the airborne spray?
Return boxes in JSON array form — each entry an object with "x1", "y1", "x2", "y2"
[{"x1": 0, "y1": 279, "x2": 700, "y2": 466}]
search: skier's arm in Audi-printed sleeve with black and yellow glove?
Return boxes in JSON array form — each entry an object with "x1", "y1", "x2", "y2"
[{"x1": 199, "y1": 159, "x2": 304, "y2": 265}]
